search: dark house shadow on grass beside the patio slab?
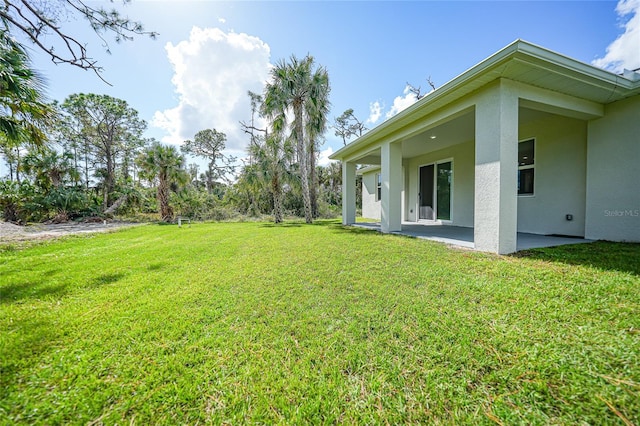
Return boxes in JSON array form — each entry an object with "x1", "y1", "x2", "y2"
[{"x1": 512, "y1": 241, "x2": 640, "y2": 276}]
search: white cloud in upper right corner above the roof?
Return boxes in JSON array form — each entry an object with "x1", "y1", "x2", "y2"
[{"x1": 592, "y1": 0, "x2": 640, "y2": 73}]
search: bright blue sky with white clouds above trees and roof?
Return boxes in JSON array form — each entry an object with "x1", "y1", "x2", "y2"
[{"x1": 12, "y1": 0, "x2": 640, "y2": 174}]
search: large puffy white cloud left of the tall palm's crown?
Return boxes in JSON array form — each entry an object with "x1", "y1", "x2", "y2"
[{"x1": 151, "y1": 27, "x2": 271, "y2": 152}]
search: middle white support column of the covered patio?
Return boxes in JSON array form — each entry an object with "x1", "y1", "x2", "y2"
[{"x1": 381, "y1": 143, "x2": 403, "y2": 232}]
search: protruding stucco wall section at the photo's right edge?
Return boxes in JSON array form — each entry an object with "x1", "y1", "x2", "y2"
[{"x1": 585, "y1": 96, "x2": 640, "y2": 242}]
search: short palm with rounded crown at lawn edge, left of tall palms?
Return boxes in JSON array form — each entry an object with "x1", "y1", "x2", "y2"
[{"x1": 138, "y1": 142, "x2": 189, "y2": 222}]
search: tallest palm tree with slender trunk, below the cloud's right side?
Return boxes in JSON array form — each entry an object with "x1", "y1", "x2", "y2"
[{"x1": 263, "y1": 55, "x2": 329, "y2": 223}]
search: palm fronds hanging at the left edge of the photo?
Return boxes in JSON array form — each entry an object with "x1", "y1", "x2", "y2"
[{"x1": 0, "y1": 30, "x2": 54, "y2": 147}]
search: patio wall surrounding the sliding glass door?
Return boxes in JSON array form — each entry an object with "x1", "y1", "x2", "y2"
[{"x1": 404, "y1": 140, "x2": 475, "y2": 227}]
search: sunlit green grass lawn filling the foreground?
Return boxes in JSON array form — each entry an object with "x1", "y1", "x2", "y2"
[{"x1": 0, "y1": 222, "x2": 640, "y2": 425}]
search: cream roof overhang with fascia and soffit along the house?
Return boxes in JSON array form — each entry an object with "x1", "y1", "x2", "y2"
[{"x1": 329, "y1": 40, "x2": 640, "y2": 160}]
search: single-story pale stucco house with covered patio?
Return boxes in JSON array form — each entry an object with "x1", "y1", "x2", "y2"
[{"x1": 331, "y1": 40, "x2": 640, "y2": 254}]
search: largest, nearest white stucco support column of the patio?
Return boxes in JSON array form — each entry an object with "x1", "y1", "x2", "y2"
[{"x1": 473, "y1": 81, "x2": 518, "y2": 254}]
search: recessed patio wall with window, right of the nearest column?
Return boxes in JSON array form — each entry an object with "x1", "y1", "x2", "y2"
[{"x1": 518, "y1": 114, "x2": 587, "y2": 237}]
